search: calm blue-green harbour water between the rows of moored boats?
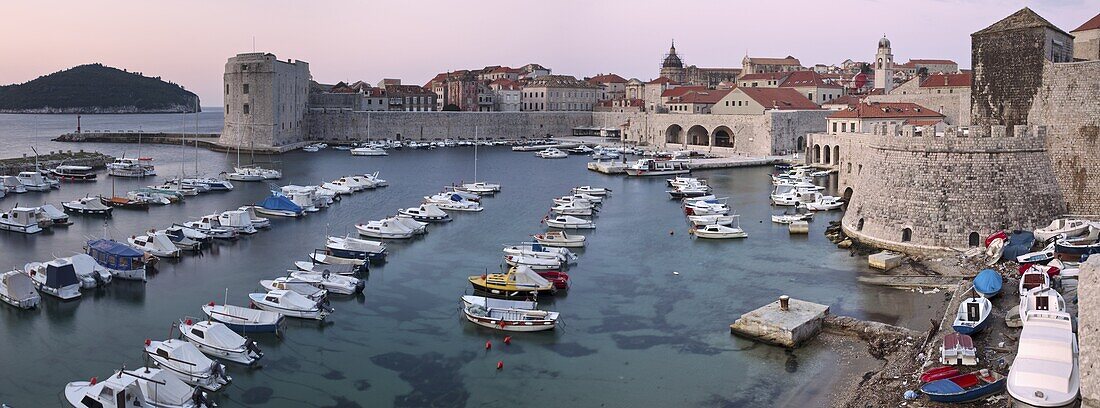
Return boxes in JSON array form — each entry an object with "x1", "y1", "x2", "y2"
[{"x1": 0, "y1": 113, "x2": 926, "y2": 408}]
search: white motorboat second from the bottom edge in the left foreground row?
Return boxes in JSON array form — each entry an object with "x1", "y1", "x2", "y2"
[{"x1": 145, "y1": 339, "x2": 233, "y2": 392}]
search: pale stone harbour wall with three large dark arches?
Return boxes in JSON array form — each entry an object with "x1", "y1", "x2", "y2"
[{"x1": 592, "y1": 110, "x2": 832, "y2": 156}]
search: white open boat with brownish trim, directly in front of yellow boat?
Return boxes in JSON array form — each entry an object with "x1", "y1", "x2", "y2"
[{"x1": 462, "y1": 296, "x2": 559, "y2": 332}]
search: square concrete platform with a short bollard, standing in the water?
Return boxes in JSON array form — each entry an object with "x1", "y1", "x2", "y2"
[{"x1": 729, "y1": 299, "x2": 828, "y2": 348}]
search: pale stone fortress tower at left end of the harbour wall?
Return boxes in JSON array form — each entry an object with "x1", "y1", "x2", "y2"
[{"x1": 218, "y1": 53, "x2": 310, "y2": 148}]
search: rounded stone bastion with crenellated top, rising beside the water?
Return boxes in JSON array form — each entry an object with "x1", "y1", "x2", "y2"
[{"x1": 807, "y1": 125, "x2": 1066, "y2": 253}]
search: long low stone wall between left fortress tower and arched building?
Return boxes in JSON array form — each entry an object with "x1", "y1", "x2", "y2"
[{"x1": 306, "y1": 109, "x2": 592, "y2": 142}]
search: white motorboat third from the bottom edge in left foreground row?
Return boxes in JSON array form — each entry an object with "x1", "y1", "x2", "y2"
[{"x1": 179, "y1": 318, "x2": 264, "y2": 365}]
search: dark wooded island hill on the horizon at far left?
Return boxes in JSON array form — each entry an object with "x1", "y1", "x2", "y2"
[{"x1": 0, "y1": 64, "x2": 199, "y2": 113}]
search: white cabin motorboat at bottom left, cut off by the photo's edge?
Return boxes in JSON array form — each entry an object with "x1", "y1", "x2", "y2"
[{"x1": 65, "y1": 367, "x2": 217, "y2": 408}]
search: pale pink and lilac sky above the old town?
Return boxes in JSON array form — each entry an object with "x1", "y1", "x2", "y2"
[{"x1": 0, "y1": 0, "x2": 1100, "y2": 106}]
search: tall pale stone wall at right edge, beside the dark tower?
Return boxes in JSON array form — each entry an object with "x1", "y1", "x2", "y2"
[{"x1": 1027, "y1": 60, "x2": 1100, "y2": 217}]
